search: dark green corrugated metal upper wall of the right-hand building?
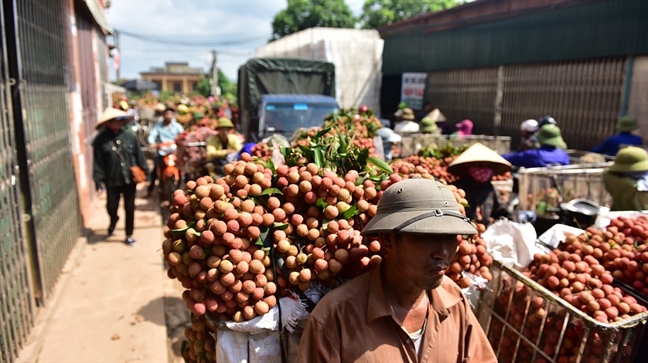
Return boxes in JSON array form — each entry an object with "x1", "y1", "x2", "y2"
[{"x1": 383, "y1": 0, "x2": 648, "y2": 75}]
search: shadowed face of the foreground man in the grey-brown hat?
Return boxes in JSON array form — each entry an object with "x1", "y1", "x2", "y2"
[{"x1": 381, "y1": 233, "x2": 458, "y2": 290}]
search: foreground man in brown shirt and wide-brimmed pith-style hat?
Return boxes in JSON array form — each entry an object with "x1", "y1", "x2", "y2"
[{"x1": 296, "y1": 178, "x2": 497, "y2": 363}]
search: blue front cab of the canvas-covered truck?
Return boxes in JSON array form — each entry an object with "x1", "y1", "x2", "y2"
[{"x1": 258, "y1": 94, "x2": 339, "y2": 140}]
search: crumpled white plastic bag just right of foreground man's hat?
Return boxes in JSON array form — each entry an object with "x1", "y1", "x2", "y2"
[{"x1": 482, "y1": 220, "x2": 538, "y2": 268}]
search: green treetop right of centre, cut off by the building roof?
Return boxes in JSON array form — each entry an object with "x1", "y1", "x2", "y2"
[{"x1": 360, "y1": 0, "x2": 465, "y2": 29}]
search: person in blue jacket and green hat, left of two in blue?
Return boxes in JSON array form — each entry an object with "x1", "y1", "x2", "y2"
[{"x1": 502, "y1": 124, "x2": 569, "y2": 168}]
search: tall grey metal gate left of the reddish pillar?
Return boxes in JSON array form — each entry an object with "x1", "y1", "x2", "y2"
[{"x1": 14, "y1": 0, "x2": 81, "y2": 301}]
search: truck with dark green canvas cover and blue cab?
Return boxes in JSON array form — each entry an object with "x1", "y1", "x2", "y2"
[{"x1": 238, "y1": 58, "x2": 339, "y2": 142}]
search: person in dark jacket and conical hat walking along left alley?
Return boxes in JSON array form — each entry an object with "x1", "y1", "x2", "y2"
[{"x1": 92, "y1": 108, "x2": 148, "y2": 246}]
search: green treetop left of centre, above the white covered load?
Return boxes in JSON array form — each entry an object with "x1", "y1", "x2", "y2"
[{"x1": 270, "y1": 0, "x2": 356, "y2": 40}]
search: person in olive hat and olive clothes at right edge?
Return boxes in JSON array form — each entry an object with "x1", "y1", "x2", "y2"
[{"x1": 603, "y1": 146, "x2": 648, "y2": 211}]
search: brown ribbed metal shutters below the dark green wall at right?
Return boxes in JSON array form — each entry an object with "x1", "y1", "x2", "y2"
[{"x1": 426, "y1": 57, "x2": 627, "y2": 150}]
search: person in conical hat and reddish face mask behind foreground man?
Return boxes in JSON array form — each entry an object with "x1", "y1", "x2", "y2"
[{"x1": 448, "y1": 143, "x2": 512, "y2": 226}]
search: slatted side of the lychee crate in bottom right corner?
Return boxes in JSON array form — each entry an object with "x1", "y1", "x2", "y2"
[{"x1": 476, "y1": 262, "x2": 648, "y2": 363}]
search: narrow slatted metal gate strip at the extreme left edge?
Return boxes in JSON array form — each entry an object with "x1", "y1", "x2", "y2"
[{"x1": 0, "y1": 0, "x2": 35, "y2": 362}]
